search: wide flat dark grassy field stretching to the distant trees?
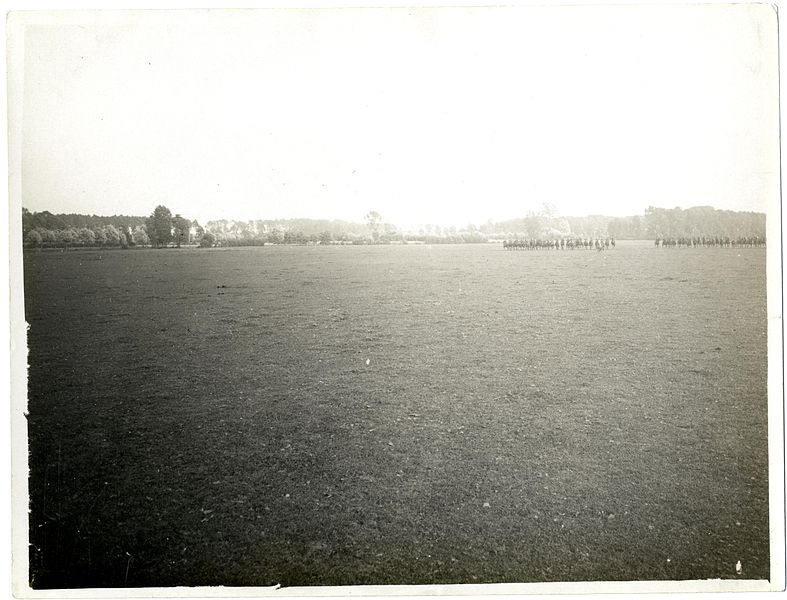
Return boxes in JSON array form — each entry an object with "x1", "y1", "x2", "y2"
[{"x1": 25, "y1": 245, "x2": 769, "y2": 588}]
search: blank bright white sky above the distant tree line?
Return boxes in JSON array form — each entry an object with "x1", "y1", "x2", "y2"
[{"x1": 12, "y1": 4, "x2": 779, "y2": 225}]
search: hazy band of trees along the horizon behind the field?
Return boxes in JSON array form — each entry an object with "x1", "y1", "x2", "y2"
[{"x1": 22, "y1": 205, "x2": 765, "y2": 248}]
